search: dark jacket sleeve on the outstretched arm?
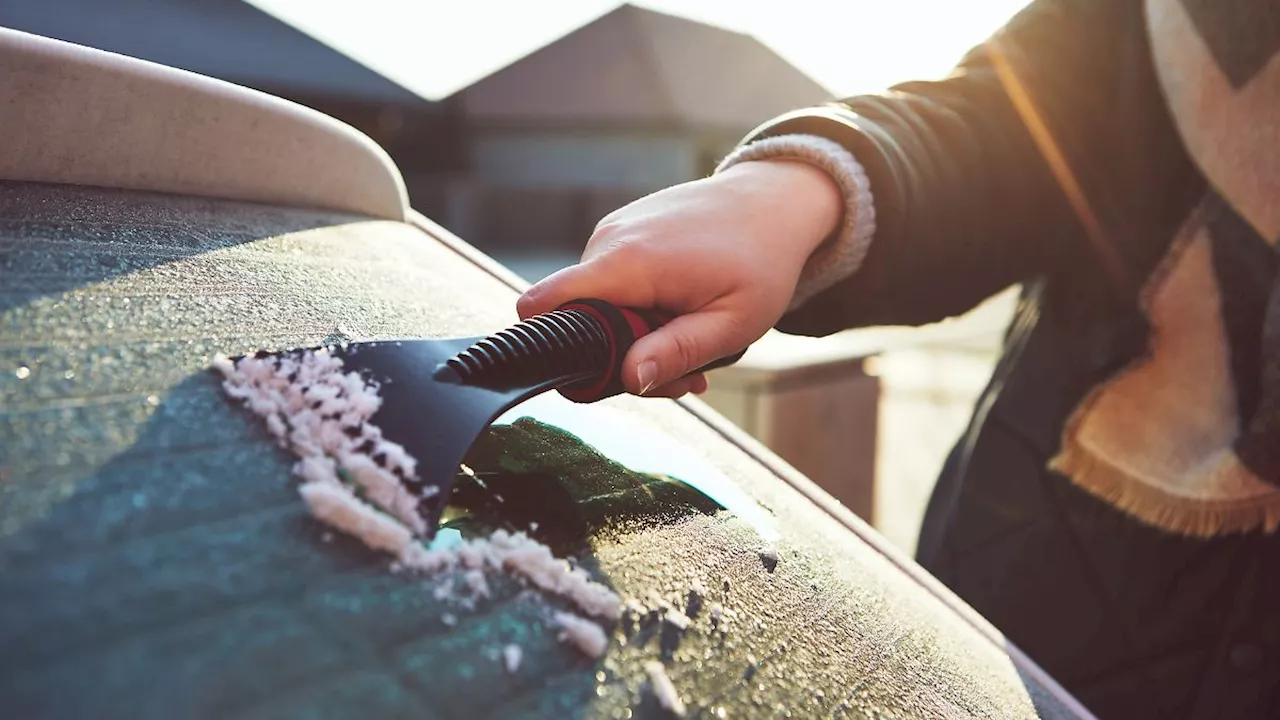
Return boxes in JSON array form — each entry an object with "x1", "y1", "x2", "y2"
[{"x1": 746, "y1": 0, "x2": 1194, "y2": 334}]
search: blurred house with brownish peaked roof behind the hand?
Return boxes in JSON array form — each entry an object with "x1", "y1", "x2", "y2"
[{"x1": 436, "y1": 5, "x2": 828, "y2": 266}]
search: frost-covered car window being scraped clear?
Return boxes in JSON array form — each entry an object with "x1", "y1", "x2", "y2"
[{"x1": 0, "y1": 182, "x2": 1085, "y2": 719}]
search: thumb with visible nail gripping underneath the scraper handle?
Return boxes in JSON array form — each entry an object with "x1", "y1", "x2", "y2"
[{"x1": 622, "y1": 310, "x2": 756, "y2": 395}]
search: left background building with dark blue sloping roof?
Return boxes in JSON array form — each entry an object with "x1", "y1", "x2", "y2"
[{"x1": 0, "y1": 0, "x2": 465, "y2": 189}]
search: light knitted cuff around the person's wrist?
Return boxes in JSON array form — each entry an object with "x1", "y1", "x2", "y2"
[{"x1": 716, "y1": 135, "x2": 876, "y2": 310}]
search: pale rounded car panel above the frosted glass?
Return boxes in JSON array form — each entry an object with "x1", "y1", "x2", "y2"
[{"x1": 0, "y1": 27, "x2": 408, "y2": 219}]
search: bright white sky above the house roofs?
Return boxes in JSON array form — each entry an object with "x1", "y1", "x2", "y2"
[{"x1": 247, "y1": 0, "x2": 1028, "y2": 100}]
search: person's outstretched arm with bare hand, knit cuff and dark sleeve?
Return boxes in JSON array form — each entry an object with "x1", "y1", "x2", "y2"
[{"x1": 517, "y1": 0, "x2": 1199, "y2": 396}]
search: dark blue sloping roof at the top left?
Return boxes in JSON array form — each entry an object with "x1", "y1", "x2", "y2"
[{"x1": 0, "y1": 0, "x2": 426, "y2": 104}]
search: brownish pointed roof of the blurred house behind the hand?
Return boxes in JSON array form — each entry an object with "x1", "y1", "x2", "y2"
[{"x1": 460, "y1": 5, "x2": 831, "y2": 128}]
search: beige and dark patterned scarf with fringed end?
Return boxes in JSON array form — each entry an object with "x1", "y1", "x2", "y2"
[{"x1": 1053, "y1": 0, "x2": 1280, "y2": 537}]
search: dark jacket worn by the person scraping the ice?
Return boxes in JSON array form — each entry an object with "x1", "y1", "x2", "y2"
[{"x1": 751, "y1": 0, "x2": 1280, "y2": 719}]
